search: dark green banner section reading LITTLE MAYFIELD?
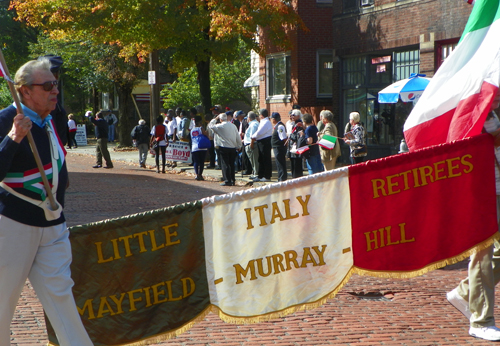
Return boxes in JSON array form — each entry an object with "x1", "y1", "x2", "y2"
[{"x1": 47, "y1": 202, "x2": 210, "y2": 345}]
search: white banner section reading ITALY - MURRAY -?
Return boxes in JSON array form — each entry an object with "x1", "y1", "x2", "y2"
[{"x1": 202, "y1": 168, "x2": 353, "y2": 321}]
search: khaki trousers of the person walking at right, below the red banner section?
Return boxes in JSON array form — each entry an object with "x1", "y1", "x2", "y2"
[{"x1": 457, "y1": 196, "x2": 500, "y2": 328}]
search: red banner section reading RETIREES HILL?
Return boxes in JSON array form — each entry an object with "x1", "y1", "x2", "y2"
[{"x1": 349, "y1": 134, "x2": 498, "y2": 277}]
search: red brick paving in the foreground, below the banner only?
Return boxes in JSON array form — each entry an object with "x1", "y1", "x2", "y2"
[{"x1": 12, "y1": 266, "x2": 498, "y2": 346}]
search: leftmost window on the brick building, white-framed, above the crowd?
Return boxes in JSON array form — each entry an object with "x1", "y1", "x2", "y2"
[{"x1": 267, "y1": 53, "x2": 292, "y2": 98}]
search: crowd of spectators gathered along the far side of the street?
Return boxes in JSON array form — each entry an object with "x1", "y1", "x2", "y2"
[{"x1": 124, "y1": 105, "x2": 366, "y2": 186}]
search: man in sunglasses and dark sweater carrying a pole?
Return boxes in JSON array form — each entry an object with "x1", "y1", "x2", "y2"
[{"x1": 0, "y1": 60, "x2": 92, "y2": 346}]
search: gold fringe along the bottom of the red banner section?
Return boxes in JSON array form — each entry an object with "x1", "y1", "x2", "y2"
[{"x1": 353, "y1": 232, "x2": 500, "y2": 279}]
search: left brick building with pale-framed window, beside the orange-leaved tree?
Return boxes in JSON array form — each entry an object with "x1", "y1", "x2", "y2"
[{"x1": 258, "y1": 0, "x2": 333, "y2": 121}]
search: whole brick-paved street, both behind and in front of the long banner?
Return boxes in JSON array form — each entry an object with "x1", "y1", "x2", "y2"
[{"x1": 8, "y1": 151, "x2": 500, "y2": 346}]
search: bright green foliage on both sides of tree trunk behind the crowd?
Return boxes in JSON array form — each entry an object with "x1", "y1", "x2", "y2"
[{"x1": 162, "y1": 50, "x2": 251, "y2": 109}]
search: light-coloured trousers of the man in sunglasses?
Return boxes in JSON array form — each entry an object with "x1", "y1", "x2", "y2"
[{"x1": 0, "y1": 215, "x2": 93, "y2": 346}]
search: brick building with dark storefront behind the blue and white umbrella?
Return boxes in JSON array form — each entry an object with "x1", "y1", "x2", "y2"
[{"x1": 332, "y1": 0, "x2": 472, "y2": 158}]
